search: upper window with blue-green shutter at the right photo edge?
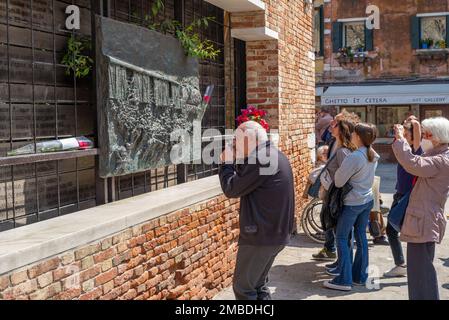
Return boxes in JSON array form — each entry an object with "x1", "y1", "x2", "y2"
[{"x1": 411, "y1": 13, "x2": 449, "y2": 49}]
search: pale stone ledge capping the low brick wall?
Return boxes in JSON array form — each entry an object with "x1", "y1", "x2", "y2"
[{"x1": 0, "y1": 176, "x2": 222, "y2": 275}]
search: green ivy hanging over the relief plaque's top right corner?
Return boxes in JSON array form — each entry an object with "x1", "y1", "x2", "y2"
[{"x1": 145, "y1": 0, "x2": 220, "y2": 60}]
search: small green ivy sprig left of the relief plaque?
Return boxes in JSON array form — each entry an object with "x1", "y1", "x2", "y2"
[{"x1": 61, "y1": 34, "x2": 94, "y2": 78}]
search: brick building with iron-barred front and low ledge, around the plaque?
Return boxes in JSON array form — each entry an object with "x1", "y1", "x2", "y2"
[{"x1": 0, "y1": 0, "x2": 315, "y2": 299}]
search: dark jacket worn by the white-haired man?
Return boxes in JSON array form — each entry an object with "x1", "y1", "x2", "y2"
[{"x1": 219, "y1": 142, "x2": 295, "y2": 246}]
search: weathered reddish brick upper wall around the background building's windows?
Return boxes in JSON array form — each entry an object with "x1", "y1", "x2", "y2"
[{"x1": 322, "y1": 0, "x2": 449, "y2": 83}]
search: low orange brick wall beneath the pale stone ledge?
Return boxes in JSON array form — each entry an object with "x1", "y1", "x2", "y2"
[{"x1": 0, "y1": 196, "x2": 238, "y2": 300}]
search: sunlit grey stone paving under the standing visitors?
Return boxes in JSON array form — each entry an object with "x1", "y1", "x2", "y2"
[{"x1": 214, "y1": 164, "x2": 449, "y2": 300}]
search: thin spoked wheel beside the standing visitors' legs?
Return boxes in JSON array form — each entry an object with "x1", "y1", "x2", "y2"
[{"x1": 301, "y1": 198, "x2": 325, "y2": 244}]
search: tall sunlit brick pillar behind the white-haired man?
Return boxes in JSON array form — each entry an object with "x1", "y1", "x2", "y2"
[{"x1": 238, "y1": 0, "x2": 315, "y2": 216}]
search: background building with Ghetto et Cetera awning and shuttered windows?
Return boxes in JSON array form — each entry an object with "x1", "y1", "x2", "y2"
[{"x1": 314, "y1": 0, "x2": 449, "y2": 159}]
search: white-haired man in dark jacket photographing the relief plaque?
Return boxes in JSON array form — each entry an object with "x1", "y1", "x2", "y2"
[{"x1": 219, "y1": 121, "x2": 295, "y2": 300}]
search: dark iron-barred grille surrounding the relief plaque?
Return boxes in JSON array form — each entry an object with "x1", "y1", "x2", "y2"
[{"x1": 0, "y1": 0, "x2": 242, "y2": 231}]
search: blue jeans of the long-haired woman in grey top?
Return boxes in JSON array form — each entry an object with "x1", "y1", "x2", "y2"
[{"x1": 332, "y1": 201, "x2": 374, "y2": 286}]
